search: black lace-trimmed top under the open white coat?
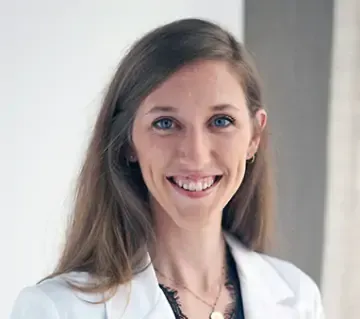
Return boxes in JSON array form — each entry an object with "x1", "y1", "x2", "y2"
[{"x1": 160, "y1": 249, "x2": 245, "y2": 319}]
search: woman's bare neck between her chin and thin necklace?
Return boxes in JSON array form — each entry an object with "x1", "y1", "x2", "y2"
[{"x1": 151, "y1": 212, "x2": 225, "y2": 291}]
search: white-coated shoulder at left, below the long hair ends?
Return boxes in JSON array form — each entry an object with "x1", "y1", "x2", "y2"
[{"x1": 10, "y1": 273, "x2": 104, "y2": 319}]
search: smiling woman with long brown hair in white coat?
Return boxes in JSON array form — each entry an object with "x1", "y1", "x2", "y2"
[{"x1": 11, "y1": 19, "x2": 323, "y2": 319}]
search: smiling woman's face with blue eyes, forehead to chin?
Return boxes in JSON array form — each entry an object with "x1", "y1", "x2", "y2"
[{"x1": 132, "y1": 61, "x2": 266, "y2": 228}]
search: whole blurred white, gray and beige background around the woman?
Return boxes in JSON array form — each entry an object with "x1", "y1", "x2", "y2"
[{"x1": 0, "y1": 0, "x2": 360, "y2": 319}]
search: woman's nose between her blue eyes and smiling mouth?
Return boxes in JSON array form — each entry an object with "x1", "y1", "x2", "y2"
[{"x1": 178, "y1": 129, "x2": 212, "y2": 170}]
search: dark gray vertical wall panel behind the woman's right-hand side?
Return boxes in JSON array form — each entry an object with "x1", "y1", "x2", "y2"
[{"x1": 244, "y1": 0, "x2": 333, "y2": 283}]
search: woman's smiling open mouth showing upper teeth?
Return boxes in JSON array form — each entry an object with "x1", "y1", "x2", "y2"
[{"x1": 167, "y1": 175, "x2": 222, "y2": 193}]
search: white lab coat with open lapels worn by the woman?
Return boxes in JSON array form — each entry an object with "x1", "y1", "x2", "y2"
[{"x1": 10, "y1": 235, "x2": 324, "y2": 319}]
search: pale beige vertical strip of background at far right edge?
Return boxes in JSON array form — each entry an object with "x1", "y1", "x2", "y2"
[{"x1": 322, "y1": 0, "x2": 360, "y2": 319}]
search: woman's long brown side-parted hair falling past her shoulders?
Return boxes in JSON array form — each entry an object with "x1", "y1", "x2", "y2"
[{"x1": 50, "y1": 19, "x2": 271, "y2": 292}]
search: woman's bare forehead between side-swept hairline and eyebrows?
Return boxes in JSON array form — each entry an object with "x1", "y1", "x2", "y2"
[{"x1": 139, "y1": 61, "x2": 245, "y2": 107}]
